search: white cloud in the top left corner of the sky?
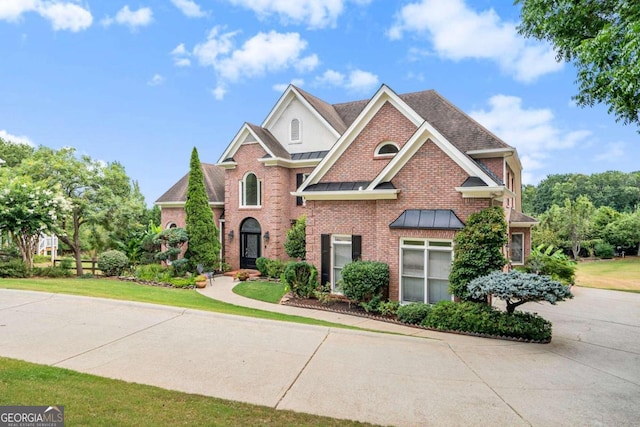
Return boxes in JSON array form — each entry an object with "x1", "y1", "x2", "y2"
[{"x1": 0, "y1": 0, "x2": 93, "y2": 32}]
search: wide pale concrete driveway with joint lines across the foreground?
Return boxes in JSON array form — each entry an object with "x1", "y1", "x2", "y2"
[{"x1": 0, "y1": 288, "x2": 640, "y2": 426}]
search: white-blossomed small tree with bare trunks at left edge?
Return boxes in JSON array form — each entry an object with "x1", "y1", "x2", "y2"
[{"x1": 0, "y1": 174, "x2": 70, "y2": 269}]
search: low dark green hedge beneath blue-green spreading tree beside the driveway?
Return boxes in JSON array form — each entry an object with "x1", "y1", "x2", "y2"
[{"x1": 421, "y1": 301, "x2": 551, "y2": 341}]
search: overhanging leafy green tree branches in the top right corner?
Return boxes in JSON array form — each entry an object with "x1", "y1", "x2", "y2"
[{"x1": 516, "y1": 0, "x2": 640, "y2": 125}]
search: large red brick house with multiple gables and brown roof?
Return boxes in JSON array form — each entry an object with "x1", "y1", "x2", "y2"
[{"x1": 156, "y1": 85, "x2": 536, "y2": 302}]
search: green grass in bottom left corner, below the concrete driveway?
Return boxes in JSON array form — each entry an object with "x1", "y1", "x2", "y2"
[{"x1": 0, "y1": 357, "x2": 370, "y2": 426}]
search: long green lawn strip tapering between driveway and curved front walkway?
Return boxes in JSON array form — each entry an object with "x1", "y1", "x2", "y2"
[{"x1": 0, "y1": 278, "x2": 362, "y2": 330}]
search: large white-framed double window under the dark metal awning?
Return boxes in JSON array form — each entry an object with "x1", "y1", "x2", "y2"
[{"x1": 400, "y1": 239, "x2": 453, "y2": 304}]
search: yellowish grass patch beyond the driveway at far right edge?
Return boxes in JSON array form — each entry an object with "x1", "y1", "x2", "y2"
[{"x1": 576, "y1": 257, "x2": 640, "y2": 292}]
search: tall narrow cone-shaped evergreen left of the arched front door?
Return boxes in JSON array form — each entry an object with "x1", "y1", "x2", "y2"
[{"x1": 184, "y1": 147, "x2": 220, "y2": 271}]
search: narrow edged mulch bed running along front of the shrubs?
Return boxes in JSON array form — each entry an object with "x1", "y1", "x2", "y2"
[{"x1": 280, "y1": 295, "x2": 551, "y2": 344}]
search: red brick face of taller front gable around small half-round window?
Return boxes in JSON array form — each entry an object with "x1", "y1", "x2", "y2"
[{"x1": 322, "y1": 102, "x2": 416, "y2": 182}]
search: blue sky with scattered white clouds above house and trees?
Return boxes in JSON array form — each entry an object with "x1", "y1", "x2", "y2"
[{"x1": 0, "y1": 0, "x2": 640, "y2": 204}]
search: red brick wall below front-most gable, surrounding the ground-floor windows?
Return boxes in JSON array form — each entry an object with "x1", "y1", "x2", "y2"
[{"x1": 307, "y1": 136, "x2": 491, "y2": 300}]
